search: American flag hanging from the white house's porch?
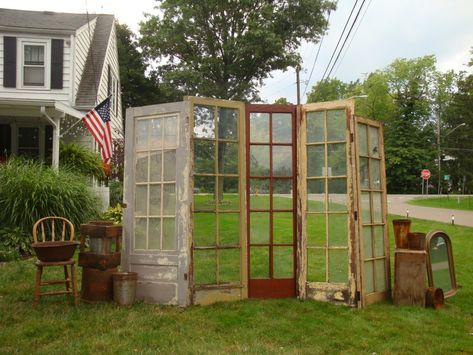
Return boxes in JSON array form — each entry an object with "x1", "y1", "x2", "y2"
[{"x1": 82, "y1": 97, "x2": 112, "y2": 163}]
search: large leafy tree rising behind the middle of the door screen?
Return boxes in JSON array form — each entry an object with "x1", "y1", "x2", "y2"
[{"x1": 140, "y1": 0, "x2": 335, "y2": 100}]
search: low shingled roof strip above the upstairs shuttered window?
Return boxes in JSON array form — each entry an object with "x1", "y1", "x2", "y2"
[{"x1": 0, "y1": 9, "x2": 97, "y2": 31}]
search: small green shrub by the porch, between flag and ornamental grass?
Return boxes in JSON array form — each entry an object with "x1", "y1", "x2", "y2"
[{"x1": 59, "y1": 142, "x2": 105, "y2": 180}]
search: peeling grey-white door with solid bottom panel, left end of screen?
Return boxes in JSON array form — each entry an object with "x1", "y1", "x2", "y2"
[{"x1": 122, "y1": 102, "x2": 190, "y2": 305}]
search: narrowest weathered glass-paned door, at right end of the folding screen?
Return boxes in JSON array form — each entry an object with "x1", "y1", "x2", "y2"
[{"x1": 356, "y1": 117, "x2": 391, "y2": 305}]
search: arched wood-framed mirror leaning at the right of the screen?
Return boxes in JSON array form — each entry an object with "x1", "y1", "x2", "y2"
[{"x1": 425, "y1": 231, "x2": 457, "y2": 298}]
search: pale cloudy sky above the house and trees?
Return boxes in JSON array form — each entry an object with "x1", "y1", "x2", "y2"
[{"x1": 0, "y1": 0, "x2": 473, "y2": 103}]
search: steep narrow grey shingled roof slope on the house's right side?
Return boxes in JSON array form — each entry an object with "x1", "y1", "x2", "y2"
[{"x1": 75, "y1": 15, "x2": 114, "y2": 108}]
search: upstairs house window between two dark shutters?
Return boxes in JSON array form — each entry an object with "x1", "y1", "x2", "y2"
[{"x1": 23, "y1": 44, "x2": 46, "y2": 86}]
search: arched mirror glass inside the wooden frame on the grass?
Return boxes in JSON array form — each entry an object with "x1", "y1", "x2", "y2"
[{"x1": 429, "y1": 236, "x2": 452, "y2": 292}]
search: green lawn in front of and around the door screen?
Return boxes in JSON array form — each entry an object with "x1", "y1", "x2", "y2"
[{"x1": 0, "y1": 216, "x2": 473, "y2": 354}]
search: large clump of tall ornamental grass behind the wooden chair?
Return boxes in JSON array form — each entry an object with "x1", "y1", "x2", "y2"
[{"x1": 0, "y1": 158, "x2": 100, "y2": 233}]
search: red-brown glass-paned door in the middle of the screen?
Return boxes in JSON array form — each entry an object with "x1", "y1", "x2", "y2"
[{"x1": 246, "y1": 104, "x2": 297, "y2": 298}]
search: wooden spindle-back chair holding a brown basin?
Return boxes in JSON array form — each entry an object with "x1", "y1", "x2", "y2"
[{"x1": 33, "y1": 217, "x2": 79, "y2": 305}]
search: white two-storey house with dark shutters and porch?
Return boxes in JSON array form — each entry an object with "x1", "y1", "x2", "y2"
[{"x1": 0, "y1": 9, "x2": 123, "y2": 166}]
